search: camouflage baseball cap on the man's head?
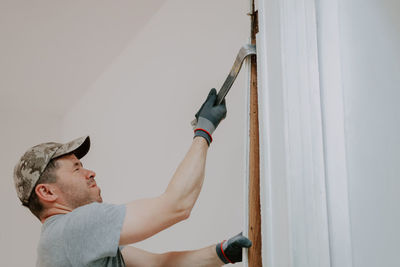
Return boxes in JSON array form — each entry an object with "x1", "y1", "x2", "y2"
[{"x1": 14, "y1": 136, "x2": 90, "y2": 204}]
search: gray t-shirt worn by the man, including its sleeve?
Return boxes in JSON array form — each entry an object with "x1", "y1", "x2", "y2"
[{"x1": 36, "y1": 202, "x2": 126, "y2": 267}]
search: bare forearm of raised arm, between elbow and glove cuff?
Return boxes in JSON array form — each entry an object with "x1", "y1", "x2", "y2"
[{"x1": 164, "y1": 137, "x2": 208, "y2": 215}]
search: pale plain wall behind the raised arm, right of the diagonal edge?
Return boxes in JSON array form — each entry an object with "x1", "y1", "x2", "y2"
[{"x1": 62, "y1": 0, "x2": 249, "y2": 262}]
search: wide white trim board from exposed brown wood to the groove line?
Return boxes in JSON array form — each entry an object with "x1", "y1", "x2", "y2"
[{"x1": 258, "y1": 0, "x2": 330, "y2": 267}]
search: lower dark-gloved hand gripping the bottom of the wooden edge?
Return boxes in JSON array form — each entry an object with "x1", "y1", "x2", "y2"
[{"x1": 215, "y1": 233, "x2": 252, "y2": 264}]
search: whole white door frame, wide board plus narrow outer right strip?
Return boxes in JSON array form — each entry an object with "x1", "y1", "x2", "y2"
[{"x1": 253, "y1": 0, "x2": 352, "y2": 267}]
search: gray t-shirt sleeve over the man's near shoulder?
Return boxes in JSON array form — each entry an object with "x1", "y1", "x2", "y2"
[{"x1": 63, "y1": 202, "x2": 126, "y2": 266}]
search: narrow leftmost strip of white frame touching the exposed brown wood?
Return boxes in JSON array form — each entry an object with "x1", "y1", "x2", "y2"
[{"x1": 257, "y1": 1, "x2": 291, "y2": 267}]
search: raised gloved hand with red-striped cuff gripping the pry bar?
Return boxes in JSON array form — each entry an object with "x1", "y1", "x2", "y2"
[{"x1": 194, "y1": 88, "x2": 226, "y2": 145}]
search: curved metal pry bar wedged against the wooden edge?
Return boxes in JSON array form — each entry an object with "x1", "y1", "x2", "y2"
[{"x1": 217, "y1": 44, "x2": 257, "y2": 105}]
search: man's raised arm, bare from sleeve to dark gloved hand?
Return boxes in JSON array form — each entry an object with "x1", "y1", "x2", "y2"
[{"x1": 119, "y1": 89, "x2": 226, "y2": 245}]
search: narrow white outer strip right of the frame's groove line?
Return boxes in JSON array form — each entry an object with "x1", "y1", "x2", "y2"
[{"x1": 317, "y1": 0, "x2": 353, "y2": 267}]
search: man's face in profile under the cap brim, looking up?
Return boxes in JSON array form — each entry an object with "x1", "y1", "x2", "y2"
[{"x1": 56, "y1": 155, "x2": 103, "y2": 209}]
